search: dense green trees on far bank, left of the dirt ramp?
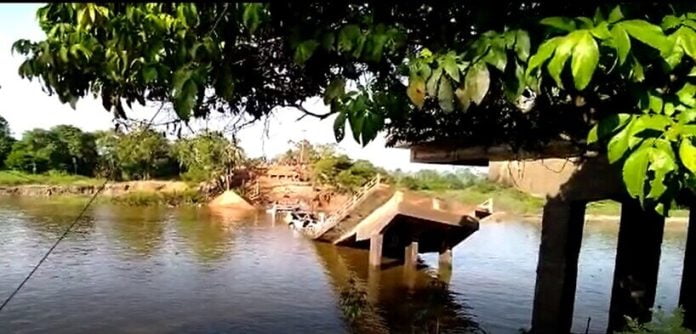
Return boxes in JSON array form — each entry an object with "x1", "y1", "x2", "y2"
[{"x1": 0, "y1": 117, "x2": 244, "y2": 184}]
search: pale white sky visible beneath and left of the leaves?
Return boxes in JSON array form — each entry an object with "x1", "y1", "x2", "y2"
[{"x1": 0, "y1": 4, "x2": 483, "y2": 171}]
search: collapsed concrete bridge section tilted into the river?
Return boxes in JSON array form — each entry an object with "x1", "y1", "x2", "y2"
[{"x1": 305, "y1": 179, "x2": 479, "y2": 267}]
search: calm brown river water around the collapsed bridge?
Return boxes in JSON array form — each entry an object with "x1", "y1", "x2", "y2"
[{"x1": 0, "y1": 197, "x2": 686, "y2": 333}]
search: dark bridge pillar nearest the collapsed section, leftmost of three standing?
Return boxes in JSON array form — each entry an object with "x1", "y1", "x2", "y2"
[{"x1": 532, "y1": 199, "x2": 585, "y2": 333}]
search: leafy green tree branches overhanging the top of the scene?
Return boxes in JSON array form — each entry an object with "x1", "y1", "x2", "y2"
[{"x1": 14, "y1": 0, "x2": 696, "y2": 214}]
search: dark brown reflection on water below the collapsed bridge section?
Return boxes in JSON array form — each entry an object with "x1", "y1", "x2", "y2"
[{"x1": 314, "y1": 243, "x2": 484, "y2": 333}]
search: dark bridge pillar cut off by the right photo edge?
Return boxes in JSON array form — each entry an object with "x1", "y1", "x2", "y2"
[{"x1": 679, "y1": 205, "x2": 696, "y2": 330}]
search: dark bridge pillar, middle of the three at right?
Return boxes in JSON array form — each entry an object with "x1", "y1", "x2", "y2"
[{"x1": 608, "y1": 201, "x2": 665, "y2": 332}]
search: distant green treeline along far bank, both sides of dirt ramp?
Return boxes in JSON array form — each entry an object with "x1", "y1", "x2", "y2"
[{"x1": 0, "y1": 117, "x2": 490, "y2": 192}]
